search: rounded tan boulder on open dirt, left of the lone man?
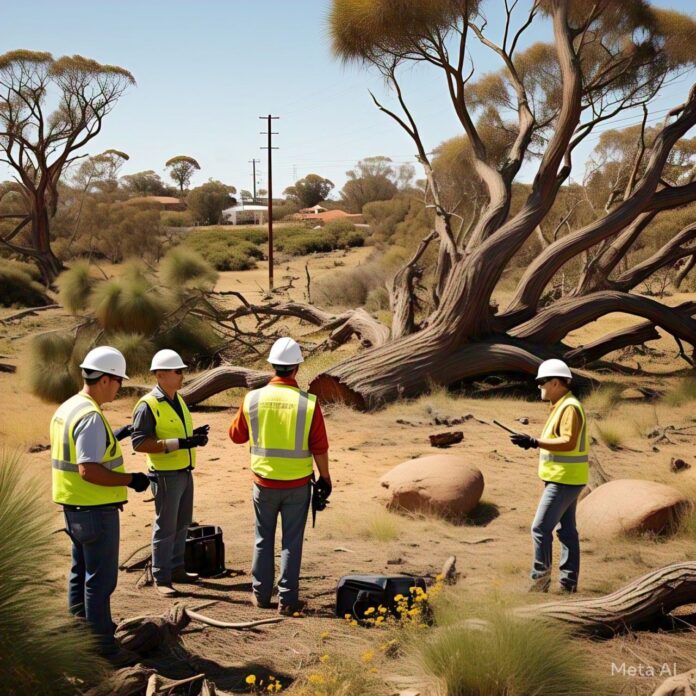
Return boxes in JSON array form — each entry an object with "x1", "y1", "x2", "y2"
[{"x1": 380, "y1": 454, "x2": 483, "y2": 517}]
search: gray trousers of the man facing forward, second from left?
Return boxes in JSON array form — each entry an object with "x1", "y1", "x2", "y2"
[{"x1": 148, "y1": 469, "x2": 193, "y2": 584}]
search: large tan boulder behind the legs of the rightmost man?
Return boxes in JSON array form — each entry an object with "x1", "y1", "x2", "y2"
[{"x1": 577, "y1": 479, "x2": 690, "y2": 538}]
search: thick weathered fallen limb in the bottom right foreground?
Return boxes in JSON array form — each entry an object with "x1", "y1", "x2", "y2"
[{"x1": 515, "y1": 561, "x2": 696, "y2": 636}]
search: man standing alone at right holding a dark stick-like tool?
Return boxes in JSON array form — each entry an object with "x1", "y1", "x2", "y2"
[{"x1": 510, "y1": 359, "x2": 589, "y2": 592}]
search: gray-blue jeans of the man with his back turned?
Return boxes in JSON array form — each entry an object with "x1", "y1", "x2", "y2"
[{"x1": 251, "y1": 484, "x2": 310, "y2": 605}]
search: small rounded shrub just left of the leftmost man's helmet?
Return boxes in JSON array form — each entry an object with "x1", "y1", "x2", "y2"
[{"x1": 27, "y1": 333, "x2": 80, "y2": 403}]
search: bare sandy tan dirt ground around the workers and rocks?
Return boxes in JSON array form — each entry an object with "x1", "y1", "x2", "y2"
[{"x1": 0, "y1": 249, "x2": 696, "y2": 694}]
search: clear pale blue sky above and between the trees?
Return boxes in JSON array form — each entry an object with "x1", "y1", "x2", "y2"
[{"x1": 0, "y1": 0, "x2": 696, "y2": 195}]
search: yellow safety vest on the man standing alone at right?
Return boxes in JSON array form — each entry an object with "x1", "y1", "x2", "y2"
[{"x1": 539, "y1": 392, "x2": 590, "y2": 486}]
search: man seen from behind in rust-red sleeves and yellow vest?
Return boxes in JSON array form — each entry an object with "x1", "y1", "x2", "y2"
[{"x1": 230, "y1": 338, "x2": 331, "y2": 615}]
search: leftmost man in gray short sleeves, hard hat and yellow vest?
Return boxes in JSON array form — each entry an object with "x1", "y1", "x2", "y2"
[{"x1": 51, "y1": 346, "x2": 148, "y2": 664}]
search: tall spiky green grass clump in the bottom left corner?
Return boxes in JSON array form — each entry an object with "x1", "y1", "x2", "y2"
[{"x1": 0, "y1": 452, "x2": 108, "y2": 695}]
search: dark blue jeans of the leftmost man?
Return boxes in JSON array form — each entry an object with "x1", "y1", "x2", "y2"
[{"x1": 64, "y1": 507, "x2": 119, "y2": 654}]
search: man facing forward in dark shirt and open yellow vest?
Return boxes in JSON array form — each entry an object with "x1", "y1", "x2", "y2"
[{"x1": 131, "y1": 349, "x2": 209, "y2": 597}]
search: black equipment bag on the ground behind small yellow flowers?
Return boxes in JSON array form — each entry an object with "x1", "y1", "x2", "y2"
[{"x1": 336, "y1": 575, "x2": 426, "y2": 621}]
